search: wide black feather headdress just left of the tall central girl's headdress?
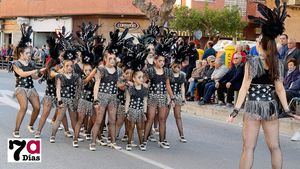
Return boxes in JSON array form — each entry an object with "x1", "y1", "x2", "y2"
[{"x1": 76, "y1": 23, "x2": 105, "y2": 65}]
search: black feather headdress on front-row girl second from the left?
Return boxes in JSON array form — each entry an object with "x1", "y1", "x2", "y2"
[{"x1": 58, "y1": 26, "x2": 77, "y2": 60}]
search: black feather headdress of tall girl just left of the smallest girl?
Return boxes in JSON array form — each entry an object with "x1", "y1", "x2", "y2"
[{"x1": 106, "y1": 29, "x2": 129, "y2": 57}]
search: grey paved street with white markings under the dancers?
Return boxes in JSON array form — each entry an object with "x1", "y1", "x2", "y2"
[{"x1": 0, "y1": 70, "x2": 300, "y2": 169}]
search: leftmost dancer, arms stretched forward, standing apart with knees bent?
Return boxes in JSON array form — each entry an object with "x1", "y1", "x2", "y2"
[{"x1": 12, "y1": 24, "x2": 45, "y2": 138}]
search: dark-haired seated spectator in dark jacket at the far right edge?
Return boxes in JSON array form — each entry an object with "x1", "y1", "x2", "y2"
[{"x1": 283, "y1": 58, "x2": 300, "y2": 90}]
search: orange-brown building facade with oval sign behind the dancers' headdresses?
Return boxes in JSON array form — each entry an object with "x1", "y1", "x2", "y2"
[{"x1": 0, "y1": 0, "x2": 162, "y2": 47}]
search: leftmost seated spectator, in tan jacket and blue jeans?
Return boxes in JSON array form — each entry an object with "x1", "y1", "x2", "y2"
[{"x1": 186, "y1": 60, "x2": 207, "y2": 101}]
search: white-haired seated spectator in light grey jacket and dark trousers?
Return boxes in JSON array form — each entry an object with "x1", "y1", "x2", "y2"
[{"x1": 198, "y1": 58, "x2": 228, "y2": 105}]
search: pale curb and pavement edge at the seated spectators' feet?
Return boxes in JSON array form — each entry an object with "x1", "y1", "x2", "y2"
[{"x1": 181, "y1": 102, "x2": 300, "y2": 136}]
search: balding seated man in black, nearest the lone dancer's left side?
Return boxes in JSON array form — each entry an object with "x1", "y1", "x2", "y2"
[{"x1": 216, "y1": 53, "x2": 245, "y2": 107}]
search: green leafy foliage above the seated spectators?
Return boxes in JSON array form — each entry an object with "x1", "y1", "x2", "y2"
[{"x1": 170, "y1": 5, "x2": 247, "y2": 39}]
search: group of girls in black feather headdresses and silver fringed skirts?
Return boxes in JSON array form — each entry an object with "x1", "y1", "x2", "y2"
[{"x1": 13, "y1": 23, "x2": 188, "y2": 151}]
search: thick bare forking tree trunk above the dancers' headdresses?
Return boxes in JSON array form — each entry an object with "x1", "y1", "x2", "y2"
[{"x1": 132, "y1": 0, "x2": 176, "y2": 26}]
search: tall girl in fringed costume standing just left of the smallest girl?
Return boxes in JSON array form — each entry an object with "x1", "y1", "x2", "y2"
[{"x1": 90, "y1": 29, "x2": 128, "y2": 151}]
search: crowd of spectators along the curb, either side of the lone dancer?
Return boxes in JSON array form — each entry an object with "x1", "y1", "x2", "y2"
[{"x1": 186, "y1": 34, "x2": 300, "y2": 111}]
